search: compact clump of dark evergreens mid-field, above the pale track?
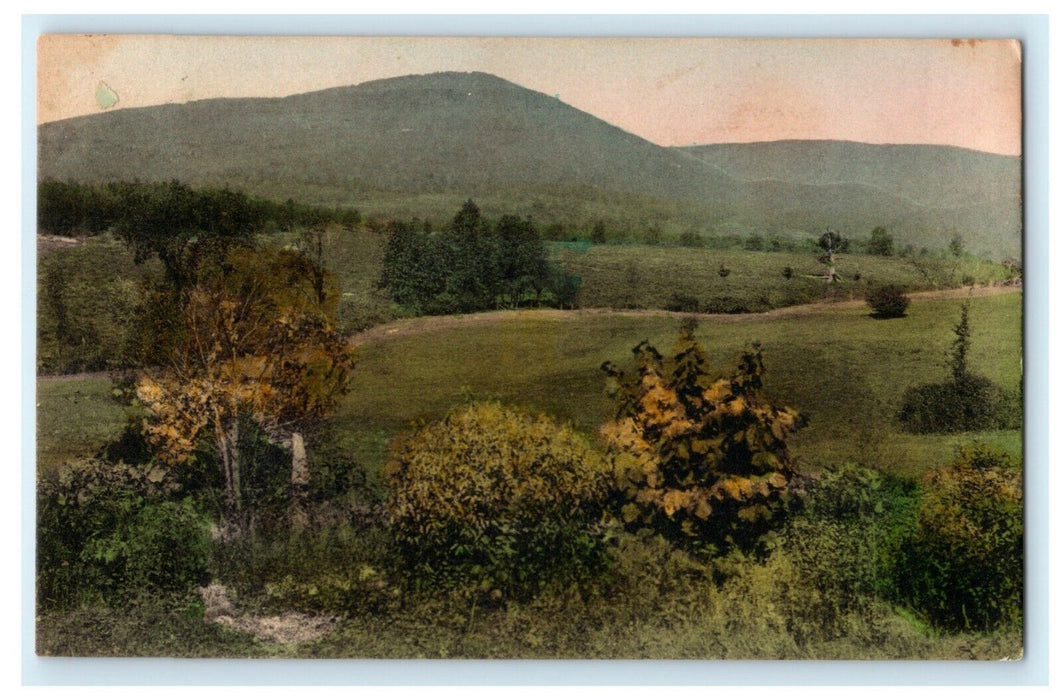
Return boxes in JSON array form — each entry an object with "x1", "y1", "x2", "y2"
[{"x1": 379, "y1": 200, "x2": 580, "y2": 314}]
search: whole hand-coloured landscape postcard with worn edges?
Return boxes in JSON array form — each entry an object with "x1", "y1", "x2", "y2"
[{"x1": 35, "y1": 34, "x2": 1024, "y2": 661}]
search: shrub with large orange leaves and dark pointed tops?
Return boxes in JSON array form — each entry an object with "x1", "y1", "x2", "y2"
[{"x1": 602, "y1": 327, "x2": 803, "y2": 551}]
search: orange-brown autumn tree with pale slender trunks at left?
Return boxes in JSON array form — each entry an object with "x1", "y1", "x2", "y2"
[{"x1": 136, "y1": 250, "x2": 353, "y2": 519}]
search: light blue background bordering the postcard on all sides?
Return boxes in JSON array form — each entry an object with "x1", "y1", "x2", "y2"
[{"x1": 21, "y1": 15, "x2": 1049, "y2": 685}]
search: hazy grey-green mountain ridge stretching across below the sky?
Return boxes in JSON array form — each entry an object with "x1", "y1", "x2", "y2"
[{"x1": 38, "y1": 73, "x2": 1020, "y2": 256}]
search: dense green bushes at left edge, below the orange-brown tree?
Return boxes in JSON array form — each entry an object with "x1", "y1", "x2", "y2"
[{"x1": 37, "y1": 460, "x2": 210, "y2": 607}]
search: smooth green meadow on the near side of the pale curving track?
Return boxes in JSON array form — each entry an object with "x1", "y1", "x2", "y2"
[{"x1": 37, "y1": 293, "x2": 1022, "y2": 482}]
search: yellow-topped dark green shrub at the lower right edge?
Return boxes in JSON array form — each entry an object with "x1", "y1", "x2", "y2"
[{"x1": 899, "y1": 445, "x2": 1023, "y2": 631}]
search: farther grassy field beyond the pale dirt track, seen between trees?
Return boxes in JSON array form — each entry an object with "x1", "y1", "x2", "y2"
[{"x1": 37, "y1": 225, "x2": 1006, "y2": 374}]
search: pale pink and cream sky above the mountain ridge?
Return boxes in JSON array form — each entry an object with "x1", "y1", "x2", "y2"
[{"x1": 38, "y1": 35, "x2": 1022, "y2": 155}]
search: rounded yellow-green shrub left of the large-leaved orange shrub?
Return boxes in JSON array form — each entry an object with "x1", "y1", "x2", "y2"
[{"x1": 386, "y1": 403, "x2": 609, "y2": 597}]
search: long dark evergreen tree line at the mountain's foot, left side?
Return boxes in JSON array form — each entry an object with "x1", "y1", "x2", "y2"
[{"x1": 37, "y1": 180, "x2": 360, "y2": 236}]
